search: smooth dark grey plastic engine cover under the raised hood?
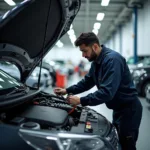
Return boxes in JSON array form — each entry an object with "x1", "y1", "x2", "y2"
[{"x1": 20, "y1": 105, "x2": 68, "y2": 126}]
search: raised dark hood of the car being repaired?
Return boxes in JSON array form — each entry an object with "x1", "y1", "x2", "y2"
[{"x1": 0, "y1": 0, "x2": 81, "y2": 82}]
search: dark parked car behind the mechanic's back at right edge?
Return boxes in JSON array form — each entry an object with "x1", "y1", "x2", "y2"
[{"x1": 132, "y1": 58, "x2": 150, "y2": 96}]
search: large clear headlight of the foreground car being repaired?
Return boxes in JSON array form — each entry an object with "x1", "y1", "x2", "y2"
[{"x1": 19, "y1": 129, "x2": 107, "y2": 150}]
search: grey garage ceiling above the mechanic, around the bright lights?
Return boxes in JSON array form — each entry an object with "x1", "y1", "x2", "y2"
[{"x1": 0, "y1": 0, "x2": 147, "y2": 47}]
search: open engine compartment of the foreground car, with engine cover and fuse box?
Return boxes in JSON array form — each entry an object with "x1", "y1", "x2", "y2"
[{"x1": 0, "y1": 92, "x2": 112, "y2": 137}]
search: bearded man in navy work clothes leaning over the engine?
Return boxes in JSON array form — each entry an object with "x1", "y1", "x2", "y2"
[{"x1": 54, "y1": 32, "x2": 142, "y2": 150}]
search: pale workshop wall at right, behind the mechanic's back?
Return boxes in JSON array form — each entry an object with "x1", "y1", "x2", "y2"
[{"x1": 106, "y1": 0, "x2": 150, "y2": 58}]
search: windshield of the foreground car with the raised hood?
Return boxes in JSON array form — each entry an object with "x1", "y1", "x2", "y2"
[{"x1": 0, "y1": 69, "x2": 22, "y2": 91}]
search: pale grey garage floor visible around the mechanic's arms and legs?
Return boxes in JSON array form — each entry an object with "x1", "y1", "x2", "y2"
[{"x1": 47, "y1": 75, "x2": 150, "y2": 150}]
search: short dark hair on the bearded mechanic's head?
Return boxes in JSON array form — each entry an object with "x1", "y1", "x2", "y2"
[{"x1": 74, "y1": 32, "x2": 100, "y2": 46}]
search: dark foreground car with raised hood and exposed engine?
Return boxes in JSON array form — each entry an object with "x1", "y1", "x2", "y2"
[{"x1": 0, "y1": 0, "x2": 119, "y2": 150}]
